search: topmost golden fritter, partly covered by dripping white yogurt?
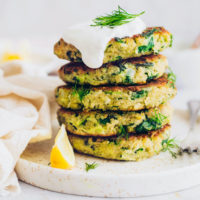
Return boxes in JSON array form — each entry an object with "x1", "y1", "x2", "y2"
[{"x1": 54, "y1": 27, "x2": 172, "y2": 63}]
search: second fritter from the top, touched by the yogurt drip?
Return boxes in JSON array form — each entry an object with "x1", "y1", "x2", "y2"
[{"x1": 59, "y1": 55, "x2": 168, "y2": 86}]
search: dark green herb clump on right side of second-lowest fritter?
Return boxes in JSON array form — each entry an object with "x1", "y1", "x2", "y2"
[{"x1": 135, "y1": 112, "x2": 167, "y2": 133}]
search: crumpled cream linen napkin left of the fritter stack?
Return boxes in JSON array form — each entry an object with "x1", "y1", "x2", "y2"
[{"x1": 0, "y1": 62, "x2": 61, "y2": 196}]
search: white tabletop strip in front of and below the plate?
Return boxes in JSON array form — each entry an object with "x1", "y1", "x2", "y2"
[{"x1": 0, "y1": 182, "x2": 200, "y2": 200}]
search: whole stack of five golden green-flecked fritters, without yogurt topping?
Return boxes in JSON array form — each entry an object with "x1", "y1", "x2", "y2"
[{"x1": 54, "y1": 27, "x2": 176, "y2": 161}]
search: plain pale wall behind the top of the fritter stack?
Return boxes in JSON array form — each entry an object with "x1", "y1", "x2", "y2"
[{"x1": 0, "y1": 0, "x2": 200, "y2": 43}]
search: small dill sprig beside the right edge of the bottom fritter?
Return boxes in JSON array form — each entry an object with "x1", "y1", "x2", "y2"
[{"x1": 162, "y1": 138, "x2": 180, "y2": 158}]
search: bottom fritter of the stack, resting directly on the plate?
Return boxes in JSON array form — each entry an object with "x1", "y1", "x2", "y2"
[{"x1": 69, "y1": 125, "x2": 170, "y2": 161}]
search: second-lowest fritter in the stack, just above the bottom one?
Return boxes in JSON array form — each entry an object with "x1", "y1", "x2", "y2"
[{"x1": 57, "y1": 103, "x2": 172, "y2": 137}]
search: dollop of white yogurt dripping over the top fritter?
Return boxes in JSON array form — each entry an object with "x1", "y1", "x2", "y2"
[{"x1": 63, "y1": 17, "x2": 146, "y2": 68}]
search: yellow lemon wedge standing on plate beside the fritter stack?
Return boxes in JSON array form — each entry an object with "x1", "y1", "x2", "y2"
[{"x1": 50, "y1": 124, "x2": 75, "y2": 169}]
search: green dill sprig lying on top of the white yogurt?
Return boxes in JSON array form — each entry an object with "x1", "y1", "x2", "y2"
[{"x1": 90, "y1": 6, "x2": 145, "y2": 28}]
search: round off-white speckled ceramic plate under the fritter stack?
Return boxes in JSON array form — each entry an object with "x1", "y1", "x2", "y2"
[{"x1": 16, "y1": 105, "x2": 200, "y2": 197}]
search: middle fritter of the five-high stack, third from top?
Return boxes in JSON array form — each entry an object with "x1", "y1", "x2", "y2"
[{"x1": 56, "y1": 76, "x2": 176, "y2": 111}]
